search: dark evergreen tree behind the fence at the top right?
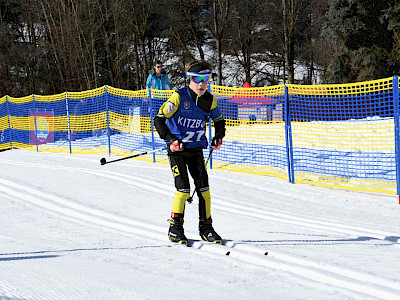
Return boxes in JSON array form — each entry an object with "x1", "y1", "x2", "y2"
[{"x1": 324, "y1": 0, "x2": 399, "y2": 83}]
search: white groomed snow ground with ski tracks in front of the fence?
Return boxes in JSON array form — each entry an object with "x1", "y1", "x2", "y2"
[{"x1": 0, "y1": 150, "x2": 400, "y2": 299}]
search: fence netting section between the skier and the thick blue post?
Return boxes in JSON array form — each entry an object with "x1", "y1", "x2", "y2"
[{"x1": 211, "y1": 85, "x2": 288, "y2": 178}]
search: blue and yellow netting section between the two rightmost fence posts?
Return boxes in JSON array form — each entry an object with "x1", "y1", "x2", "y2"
[{"x1": 288, "y1": 78, "x2": 396, "y2": 192}]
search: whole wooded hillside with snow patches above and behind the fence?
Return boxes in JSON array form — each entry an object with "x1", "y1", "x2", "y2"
[{"x1": 0, "y1": 0, "x2": 400, "y2": 97}]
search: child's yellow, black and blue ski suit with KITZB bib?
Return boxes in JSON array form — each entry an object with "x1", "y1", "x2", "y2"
[{"x1": 154, "y1": 87, "x2": 225, "y2": 219}]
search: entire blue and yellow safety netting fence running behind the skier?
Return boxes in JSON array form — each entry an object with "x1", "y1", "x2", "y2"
[{"x1": 0, "y1": 78, "x2": 399, "y2": 194}]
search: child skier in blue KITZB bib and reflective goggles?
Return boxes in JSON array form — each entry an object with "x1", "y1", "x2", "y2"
[{"x1": 154, "y1": 61, "x2": 225, "y2": 243}]
